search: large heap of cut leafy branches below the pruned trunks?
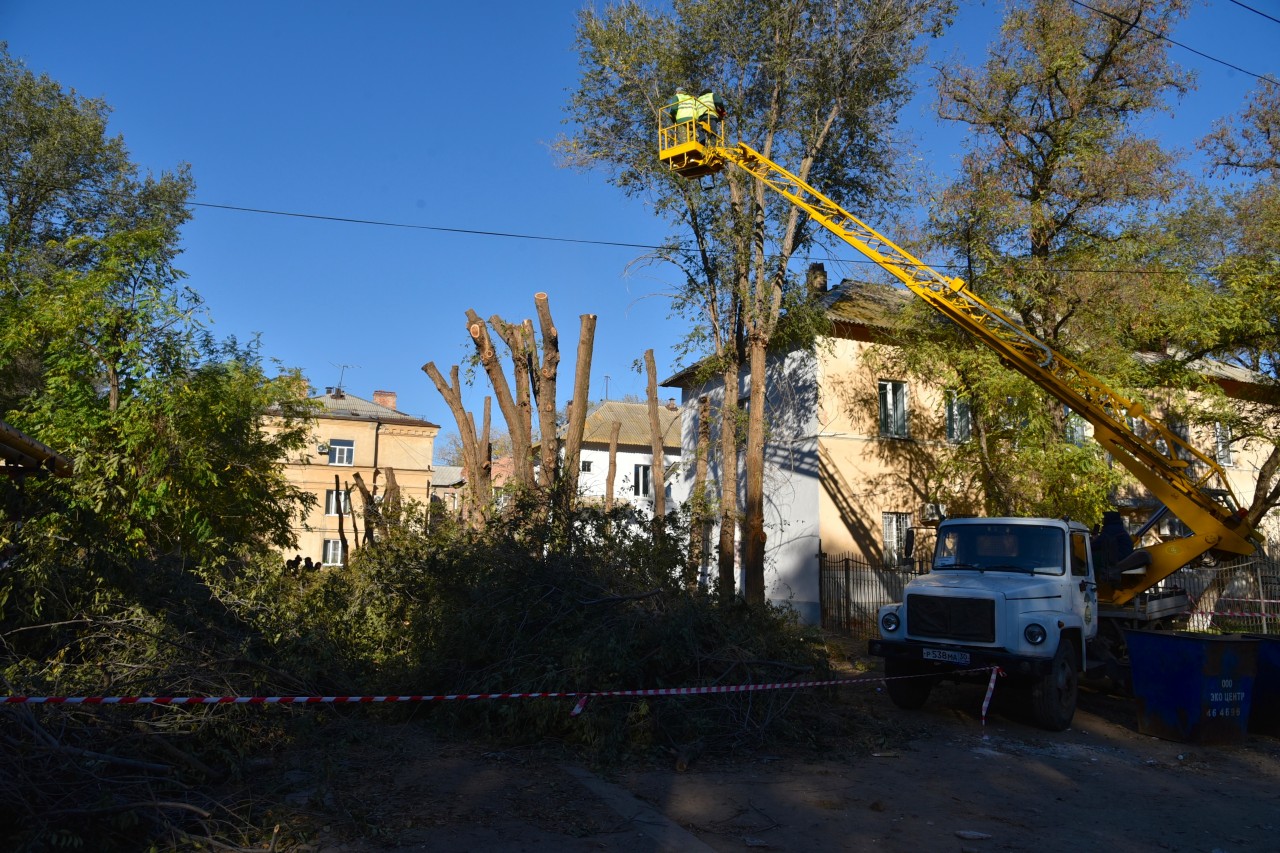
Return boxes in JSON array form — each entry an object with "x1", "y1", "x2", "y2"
[{"x1": 254, "y1": 498, "x2": 826, "y2": 757}]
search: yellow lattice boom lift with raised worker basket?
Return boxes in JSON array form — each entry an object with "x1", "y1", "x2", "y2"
[{"x1": 658, "y1": 101, "x2": 1261, "y2": 607}]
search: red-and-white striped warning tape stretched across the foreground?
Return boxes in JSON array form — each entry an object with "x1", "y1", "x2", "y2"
[{"x1": 0, "y1": 666, "x2": 998, "y2": 716}]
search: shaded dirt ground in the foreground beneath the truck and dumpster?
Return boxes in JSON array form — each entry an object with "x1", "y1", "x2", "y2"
[{"x1": 257, "y1": 655, "x2": 1280, "y2": 853}]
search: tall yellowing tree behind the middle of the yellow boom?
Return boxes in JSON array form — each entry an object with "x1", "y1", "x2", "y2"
[{"x1": 914, "y1": 0, "x2": 1192, "y2": 517}]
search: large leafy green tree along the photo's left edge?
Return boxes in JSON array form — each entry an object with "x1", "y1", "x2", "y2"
[{"x1": 0, "y1": 50, "x2": 307, "y2": 616}]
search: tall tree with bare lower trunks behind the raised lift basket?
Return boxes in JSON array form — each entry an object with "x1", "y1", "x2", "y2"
[{"x1": 561, "y1": 0, "x2": 951, "y2": 602}]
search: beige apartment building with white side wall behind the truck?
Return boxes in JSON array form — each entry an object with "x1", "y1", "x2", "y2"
[{"x1": 663, "y1": 275, "x2": 1280, "y2": 624}]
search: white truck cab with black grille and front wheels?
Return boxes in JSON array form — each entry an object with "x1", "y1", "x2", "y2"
[{"x1": 869, "y1": 519, "x2": 1098, "y2": 731}]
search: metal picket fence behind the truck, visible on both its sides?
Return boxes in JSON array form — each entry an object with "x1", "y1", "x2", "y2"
[{"x1": 819, "y1": 553, "x2": 1280, "y2": 639}]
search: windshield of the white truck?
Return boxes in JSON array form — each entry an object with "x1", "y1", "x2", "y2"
[{"x1": 933, "y1": 523, "x2": 1066, "y2": 575}]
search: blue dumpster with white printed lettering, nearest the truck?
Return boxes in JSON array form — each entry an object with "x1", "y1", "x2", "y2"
[{"x1": 1125, "y1": 630, "x2": 1258, "y2": 744}]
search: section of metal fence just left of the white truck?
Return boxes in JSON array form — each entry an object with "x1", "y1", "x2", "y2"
[{"x1": 819, "y1": 553, "x2": 928, "y2": 639}]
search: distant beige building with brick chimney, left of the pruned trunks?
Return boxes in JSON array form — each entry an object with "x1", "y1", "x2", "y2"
[{"x1": 268, "y1": 388, "x2": 437, "y2": 566}]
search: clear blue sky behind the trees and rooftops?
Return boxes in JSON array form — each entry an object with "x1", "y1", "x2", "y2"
[{"x1": 0, "y1": 0, "x2": 1280, "y2": 432}]
